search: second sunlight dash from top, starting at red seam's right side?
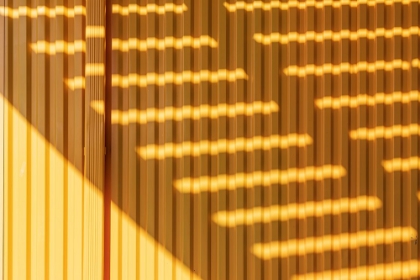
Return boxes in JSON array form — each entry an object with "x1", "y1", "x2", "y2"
[{"x1": 112, "y1": 35, "x2": 217, "y2": 52}]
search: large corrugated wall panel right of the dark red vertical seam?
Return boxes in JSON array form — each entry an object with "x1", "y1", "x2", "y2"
[{"x1": 109, "y1": 0, "x2": 420, "y2": 279}]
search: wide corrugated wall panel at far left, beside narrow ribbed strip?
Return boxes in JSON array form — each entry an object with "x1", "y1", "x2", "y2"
[{"x1": 0, "y1": 0, "x2": 102, "y2": 279}]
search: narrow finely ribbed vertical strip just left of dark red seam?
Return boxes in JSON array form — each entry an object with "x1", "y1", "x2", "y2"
[{"x1": 83, "y1": 0, "x2": 105, "y2": 279}]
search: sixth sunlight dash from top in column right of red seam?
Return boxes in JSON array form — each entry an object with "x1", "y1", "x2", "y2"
[{"x1": 174, "y1": 165, "x2": 346, "y2": 193}]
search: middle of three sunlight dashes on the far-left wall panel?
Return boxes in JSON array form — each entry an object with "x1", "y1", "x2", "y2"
[{"x1": 30, "y1": 40, "x2": 86, "y2": 55}]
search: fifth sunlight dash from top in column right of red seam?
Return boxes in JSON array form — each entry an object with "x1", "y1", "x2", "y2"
[{"x1": 137, "y1": 134, "x2": 312, "y2": 159}]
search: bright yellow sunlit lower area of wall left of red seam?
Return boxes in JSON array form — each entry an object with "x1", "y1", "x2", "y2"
[{"x1": 0, "y1": 97, "x2": 103, "y2": 279}]
